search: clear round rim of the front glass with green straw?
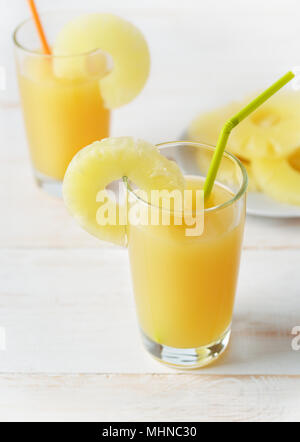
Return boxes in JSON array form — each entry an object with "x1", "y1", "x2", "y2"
[{"x1": 123, "y1": 140, "x2": 248, "y2": 215}]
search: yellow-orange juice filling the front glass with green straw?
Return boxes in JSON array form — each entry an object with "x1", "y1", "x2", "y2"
[{"x1": 128, "y1": 177, "x2": 245, "y2": 348}]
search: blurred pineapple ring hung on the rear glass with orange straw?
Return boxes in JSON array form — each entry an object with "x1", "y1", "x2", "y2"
[{"x1": 53, "y1": 13, "x2": 150, "y2": 109}]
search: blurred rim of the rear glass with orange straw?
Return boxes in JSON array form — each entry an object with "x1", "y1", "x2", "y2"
[{"x1": 12, "y1": 11, "x2": 105, "y2": 59}]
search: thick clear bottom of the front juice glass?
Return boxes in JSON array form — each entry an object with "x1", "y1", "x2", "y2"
[{"x1": 141, "y1": 327, "x2": 231, "y2": 369}]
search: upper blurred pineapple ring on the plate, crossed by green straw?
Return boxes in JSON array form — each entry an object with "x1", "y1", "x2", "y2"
[{"x1": 189, "y1": 92, "x2": 300, "y2": 160}]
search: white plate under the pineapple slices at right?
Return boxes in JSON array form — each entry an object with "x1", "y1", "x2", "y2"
[{"x1": 247, "y1": 192, "x2": 300, "y2": 218}]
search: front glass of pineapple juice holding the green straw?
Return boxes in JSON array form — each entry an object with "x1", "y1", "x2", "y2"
[{"x1": 127, "y1": 142, "x2": 247, "y2": 368}]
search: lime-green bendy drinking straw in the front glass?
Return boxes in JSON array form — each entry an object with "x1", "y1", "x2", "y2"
[{"x1": 204, "y1": 72, "x2": 295, "y2": 199}]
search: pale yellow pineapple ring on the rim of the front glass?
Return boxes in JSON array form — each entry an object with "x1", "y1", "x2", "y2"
[{"x1": 63, "y1": 137, "x2": 184, "y2": 246}]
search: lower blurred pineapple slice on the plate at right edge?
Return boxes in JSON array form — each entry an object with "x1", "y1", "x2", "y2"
[{"x1": 252, "y1": 158, "x2": 300, "y2": 206}]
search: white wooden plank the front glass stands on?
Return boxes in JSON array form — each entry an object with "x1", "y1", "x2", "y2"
[{"x1": 0, "y1": 248, "x2": 300, "y2": 375}]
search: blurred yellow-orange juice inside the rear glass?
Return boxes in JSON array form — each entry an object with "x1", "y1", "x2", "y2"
[{"x1": 18, "y1": 56, "x2": 110, "y2": 181}]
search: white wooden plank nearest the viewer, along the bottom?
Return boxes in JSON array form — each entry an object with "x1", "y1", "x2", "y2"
[{"x1": 0, "y1": 375, "x2": 300, "y2": 422}]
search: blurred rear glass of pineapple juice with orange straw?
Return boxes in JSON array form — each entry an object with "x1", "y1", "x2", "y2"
[{"x1": 13, "y1": 13, "x2": 112, "y2": 196}]
